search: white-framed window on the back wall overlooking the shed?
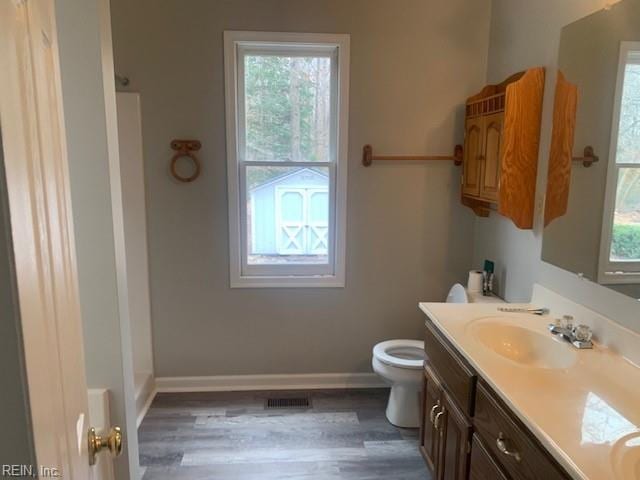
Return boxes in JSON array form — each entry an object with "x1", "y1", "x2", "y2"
[{"x1": 225, "y1": 32, "x2": 349, "y2": 287}]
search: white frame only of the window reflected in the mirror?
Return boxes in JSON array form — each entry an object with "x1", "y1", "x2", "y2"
[{"x1": 598, "y1": 42, "x2": 640, "y2": 285}]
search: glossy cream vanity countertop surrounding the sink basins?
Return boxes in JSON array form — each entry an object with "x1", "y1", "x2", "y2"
[{"x1": 420, "y1": 303, "x2": 640, "y2": 480}]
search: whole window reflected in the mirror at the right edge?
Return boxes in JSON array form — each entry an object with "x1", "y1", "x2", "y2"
[{"x1": 598, "y1": 42, "x2": 640, "y2": 284}]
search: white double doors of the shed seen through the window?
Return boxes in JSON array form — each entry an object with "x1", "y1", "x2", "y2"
[{"x1": 276, "y1": 187, "x2": 329, "y2": 255}]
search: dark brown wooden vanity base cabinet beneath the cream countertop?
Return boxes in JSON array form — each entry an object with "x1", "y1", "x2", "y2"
[{"x1": 420, "y1": 318, "x2": 570, "y2": 480}]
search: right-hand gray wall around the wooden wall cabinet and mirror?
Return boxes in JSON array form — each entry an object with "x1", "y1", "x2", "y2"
[{"x1": 474, "y1": 0, "x2": 640, "y2": 330}]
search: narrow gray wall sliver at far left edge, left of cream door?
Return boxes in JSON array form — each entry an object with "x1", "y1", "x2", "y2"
[{"x1": 0, "y1": 131, "x2": 35, "y2": 465}]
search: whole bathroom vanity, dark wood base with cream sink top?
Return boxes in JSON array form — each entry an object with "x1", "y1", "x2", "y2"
[{"x1": 420, "y1": 284, "x2": 640, "y2": 480}]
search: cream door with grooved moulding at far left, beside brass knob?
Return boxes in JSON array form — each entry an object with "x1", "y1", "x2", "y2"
[{"x1": 0, "y1": 0, "x2": 120, "y2": 480}]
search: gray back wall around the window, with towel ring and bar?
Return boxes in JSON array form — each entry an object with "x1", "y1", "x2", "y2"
[{"x1": 112, "y1": 0, "x2": 490, "y2": 376}]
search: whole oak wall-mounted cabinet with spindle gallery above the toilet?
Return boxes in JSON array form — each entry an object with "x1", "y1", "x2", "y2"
[{"x1": 462, "y1": 68, "x2": 544, "y2": 229}]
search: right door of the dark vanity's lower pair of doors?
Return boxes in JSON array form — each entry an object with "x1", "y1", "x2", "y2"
[{"x1": 436, "y1": 393, "x2": 471, "y2": 480}]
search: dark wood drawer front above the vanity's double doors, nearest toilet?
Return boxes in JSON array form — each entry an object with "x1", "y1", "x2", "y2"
[{"x1": 424, "y1": 320, "x2": 477, "y2": 416}]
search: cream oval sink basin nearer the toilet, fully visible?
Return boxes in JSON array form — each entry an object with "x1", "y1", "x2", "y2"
[{"x1": 468, "y1": 317, "x2": 576, "y2": 369}]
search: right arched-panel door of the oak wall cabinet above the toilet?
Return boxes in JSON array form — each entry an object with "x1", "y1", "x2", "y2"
[{"x1": 480, "y1": 112, "x2": 504, "y2": 202}]
